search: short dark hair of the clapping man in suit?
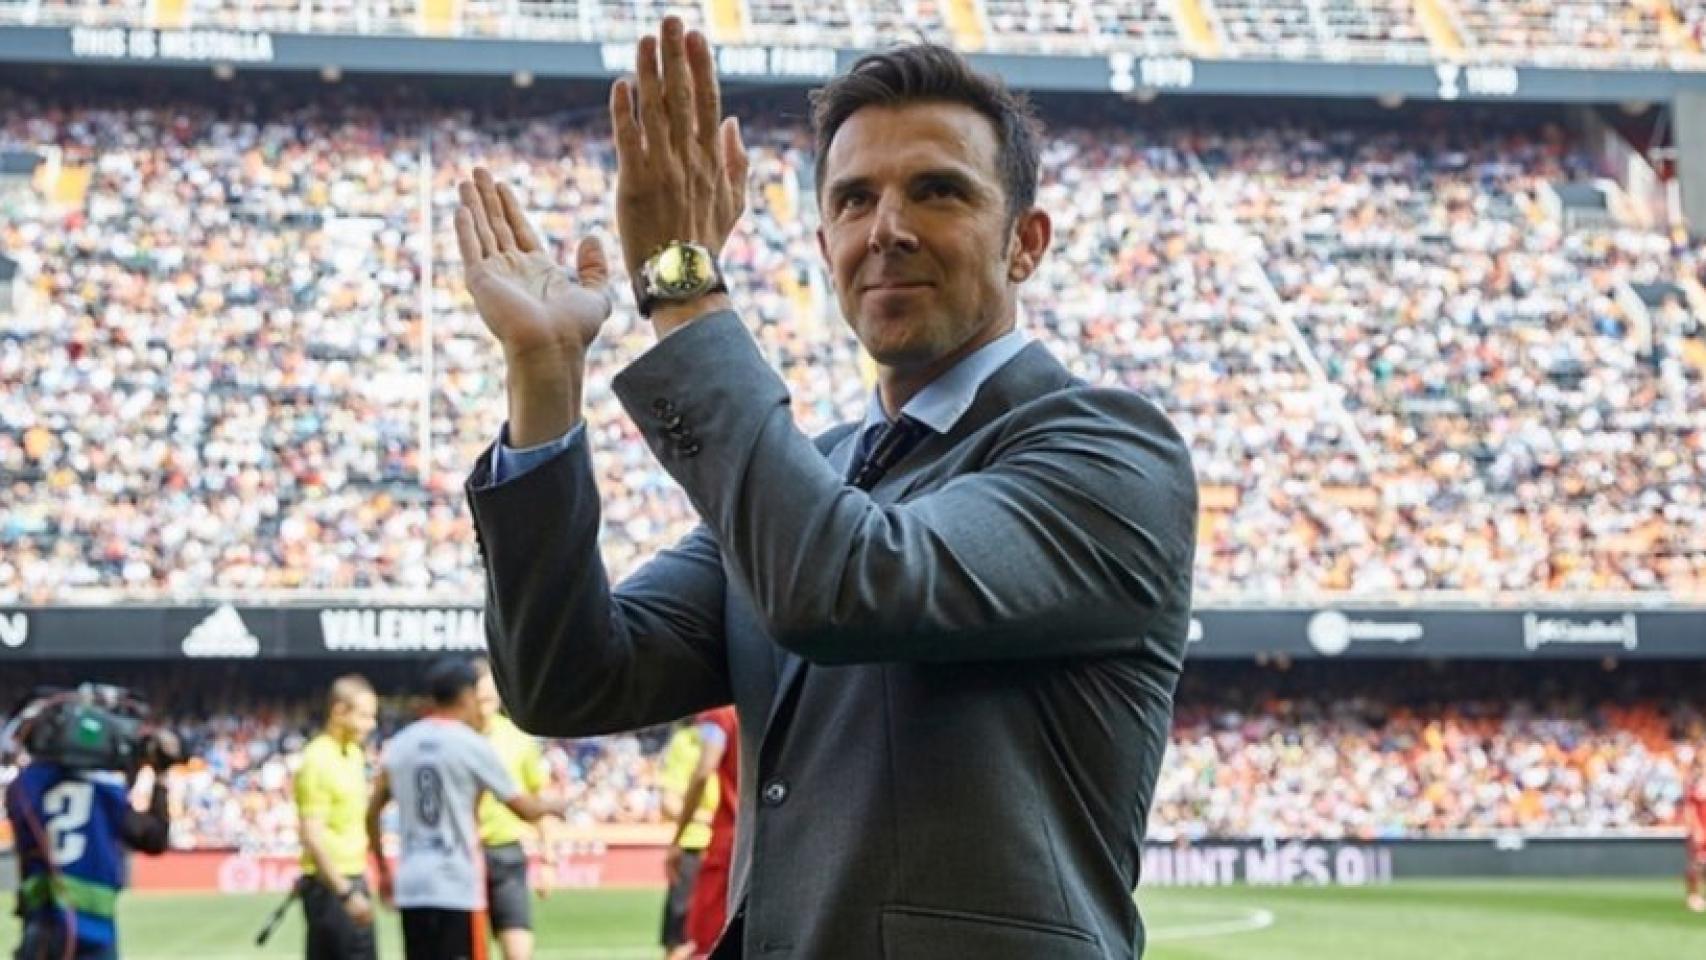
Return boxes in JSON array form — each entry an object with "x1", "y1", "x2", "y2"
[{"x1": 810, "y1": 43, "x2": 1042, "y2": 223}]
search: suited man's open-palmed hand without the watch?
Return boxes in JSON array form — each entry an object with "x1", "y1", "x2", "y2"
[{"x1": 456, "y1": 167, "x2": 611, "y2": 364}]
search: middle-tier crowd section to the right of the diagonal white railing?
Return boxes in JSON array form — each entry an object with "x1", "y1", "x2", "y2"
[{"x1": 1204, "y1": 121, "x2": 1706, "y2": 597}]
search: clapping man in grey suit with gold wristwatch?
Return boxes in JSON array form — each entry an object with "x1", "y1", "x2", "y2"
[{"x1": 457, "y1": 19, "x2": 1196, "y2": 960}]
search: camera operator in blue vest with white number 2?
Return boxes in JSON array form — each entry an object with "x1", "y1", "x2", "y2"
[{"x1": 5, "y1": 694, "x2": 181, "y2": 960}]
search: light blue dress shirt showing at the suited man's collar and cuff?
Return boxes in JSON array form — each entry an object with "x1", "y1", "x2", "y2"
[{"x1": 491, "y1": 322, "x2": 1030, "y2": 486}]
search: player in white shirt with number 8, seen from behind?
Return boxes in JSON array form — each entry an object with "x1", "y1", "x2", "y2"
[{"x1": 367, "y1": 660, "x2": 566, "y2": 960}]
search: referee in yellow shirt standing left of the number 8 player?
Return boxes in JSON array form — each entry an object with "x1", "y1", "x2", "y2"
[{"x1": 292, "y1": 674, "x2": 379, "y2": 960}]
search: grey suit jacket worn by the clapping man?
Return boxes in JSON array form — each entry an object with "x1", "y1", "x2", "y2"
[{"x1": 469, "y1": 314, "x2": 1196, "y2": 960}]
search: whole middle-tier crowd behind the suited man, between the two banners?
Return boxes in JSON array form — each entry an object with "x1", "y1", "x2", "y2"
[{"x1": 0, "y1": 97, "x2": 1706, "y2": 602}]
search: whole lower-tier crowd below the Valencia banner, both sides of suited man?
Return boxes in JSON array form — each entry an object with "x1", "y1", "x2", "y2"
[{"x1": 0, "y1": 680, "x2": 1706, "y2": 854}]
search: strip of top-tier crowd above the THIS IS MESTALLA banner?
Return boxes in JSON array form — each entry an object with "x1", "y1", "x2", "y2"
[{"x1": 0, "y1": 0, "x2": 1701, "y2": 67}]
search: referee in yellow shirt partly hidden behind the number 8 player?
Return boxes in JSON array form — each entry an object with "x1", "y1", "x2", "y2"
[{"x1": 474, "y1": 660, "x2": 551, "y2": 960}]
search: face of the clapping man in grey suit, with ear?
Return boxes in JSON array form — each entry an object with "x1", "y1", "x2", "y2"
[{"x1": 817, "y1": 102, "x2": 1047, "y2": 370}]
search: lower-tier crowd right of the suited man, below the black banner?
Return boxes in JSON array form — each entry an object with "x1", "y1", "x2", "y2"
[{"x1": 1150, "y1": 696, "x2": 1706, "y2": 839}]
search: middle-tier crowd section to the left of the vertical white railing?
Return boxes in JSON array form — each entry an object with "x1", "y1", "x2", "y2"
[{"x1": 0, "y1": 101, "x2": 433, "y2": 602}]
